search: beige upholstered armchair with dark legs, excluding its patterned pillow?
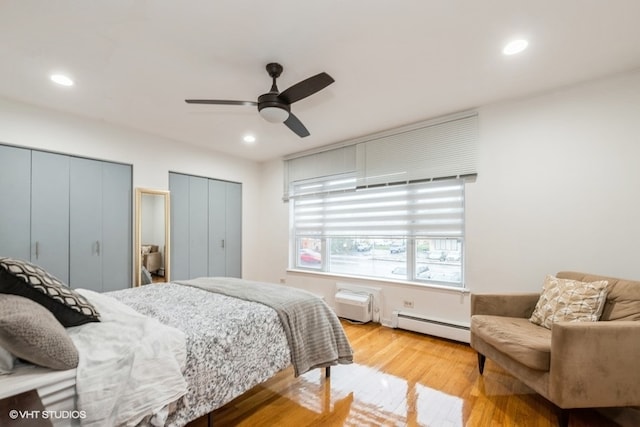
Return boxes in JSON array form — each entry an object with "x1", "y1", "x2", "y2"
[{"x1": 471, "y1": 272, "x2": 640, "y2": 426}]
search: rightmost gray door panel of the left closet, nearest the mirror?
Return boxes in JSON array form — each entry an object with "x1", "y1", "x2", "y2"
[{"x1": 100, "y1": 162, "x2": 133, "y2": 292}]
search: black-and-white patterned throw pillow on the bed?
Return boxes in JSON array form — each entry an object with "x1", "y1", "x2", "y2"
[{"x1": 0, "y1": 258, "x2": 100, "y2": 327}]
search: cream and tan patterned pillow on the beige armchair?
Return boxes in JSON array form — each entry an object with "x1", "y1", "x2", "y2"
[{"x1": 529, "y1": 275, "x2": 608, "y2": 329}]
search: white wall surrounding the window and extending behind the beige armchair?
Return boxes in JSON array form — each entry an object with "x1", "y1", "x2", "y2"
[{"x1": 259, "y1": 72, "x2": 640, "y2": 323}]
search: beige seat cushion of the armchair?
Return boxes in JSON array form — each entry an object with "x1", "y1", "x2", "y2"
[{"x1": 471, "y1": 314, "x2": 551, "y2": 371}]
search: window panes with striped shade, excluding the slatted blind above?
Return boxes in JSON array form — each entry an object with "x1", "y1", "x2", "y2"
[{"x1": 290, "y1": 175, "x2": 464, "y2": 286}]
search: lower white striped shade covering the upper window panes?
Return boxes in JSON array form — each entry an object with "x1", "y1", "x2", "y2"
[{"x1": 293, "y1": 179, "x2": 464, "y2": 238}]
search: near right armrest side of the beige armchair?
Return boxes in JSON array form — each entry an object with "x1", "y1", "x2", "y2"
[{"x1": 549, "y1": 321, "x2": 640, "y2": 408}]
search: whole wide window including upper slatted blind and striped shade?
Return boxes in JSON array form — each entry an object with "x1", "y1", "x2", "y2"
[{"x1": 283, "y1": 112, "x2": 478, "y2": 287}]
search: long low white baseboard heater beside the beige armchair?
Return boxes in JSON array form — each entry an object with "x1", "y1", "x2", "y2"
[{"x1": 391, "y1": 311, "x2": 470, "y2": 343}]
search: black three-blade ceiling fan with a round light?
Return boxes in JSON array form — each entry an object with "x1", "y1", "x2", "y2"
[{"x1": 185, "y1": 62, "x2": 334, "y2": 138}]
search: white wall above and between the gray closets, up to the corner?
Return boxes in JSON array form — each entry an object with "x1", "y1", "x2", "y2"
[{"x1": 0, "y1": 98, "x2": 260, "y2": 278}]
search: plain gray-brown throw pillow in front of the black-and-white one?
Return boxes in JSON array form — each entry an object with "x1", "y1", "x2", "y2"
[{"x1": 0, "y1": 294, "x2": 78, "y2": 369}]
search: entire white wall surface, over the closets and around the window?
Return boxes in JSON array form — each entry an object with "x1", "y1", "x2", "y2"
[{"x1": 5, "y1": 68, "x2": 640, "y2": 322}]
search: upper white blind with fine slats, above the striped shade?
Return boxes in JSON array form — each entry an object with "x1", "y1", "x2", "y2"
[{"x1": 284, "y1": 112, "x2": 478, "y2": 200}]
